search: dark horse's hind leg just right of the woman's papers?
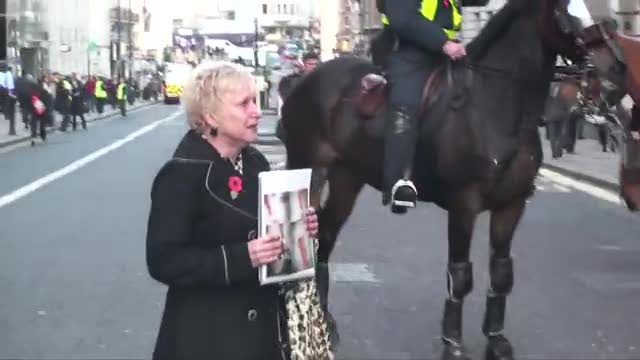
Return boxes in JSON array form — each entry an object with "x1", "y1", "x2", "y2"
[{"x1": 316, "y1": 165, "x2": 364, "y2": 346}]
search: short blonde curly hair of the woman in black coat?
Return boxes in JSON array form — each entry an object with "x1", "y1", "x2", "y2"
[{"x1": 181, "y1": 61, "x2": 256, "y2": 131}]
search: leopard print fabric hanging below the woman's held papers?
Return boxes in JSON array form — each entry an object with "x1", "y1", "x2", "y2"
[{"x1": 285, "y1": 279, "x2": 334, "y2": 360}]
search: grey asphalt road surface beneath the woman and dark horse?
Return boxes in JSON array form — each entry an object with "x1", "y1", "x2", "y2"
[{"x1": 0, "y1": 105, "x2": 640, "y2": 359}]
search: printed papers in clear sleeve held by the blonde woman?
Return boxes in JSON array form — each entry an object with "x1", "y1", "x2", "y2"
[{"x1": 258, "y1": 169, "x2": 316, "y2": 285}]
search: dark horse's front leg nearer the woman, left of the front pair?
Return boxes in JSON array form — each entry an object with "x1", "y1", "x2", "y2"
[{"x1": 442, "y1": 208, "x2": 477, "y2": 359}]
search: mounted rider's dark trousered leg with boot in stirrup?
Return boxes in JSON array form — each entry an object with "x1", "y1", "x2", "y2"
[{"x1": 383, "y1": 52, "x2": 431, "y2": 212}]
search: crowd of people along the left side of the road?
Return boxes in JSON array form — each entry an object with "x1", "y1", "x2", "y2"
[{"x1": 0, "y1": 64, "x2": 161, "y2": 145}]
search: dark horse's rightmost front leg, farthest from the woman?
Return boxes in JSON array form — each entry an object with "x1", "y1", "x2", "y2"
[{"x1": 482, "y1": 199, "x2": 526, "y2": 360}]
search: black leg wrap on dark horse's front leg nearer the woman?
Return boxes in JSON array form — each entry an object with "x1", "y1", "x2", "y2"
[{"x1": 442, "y1": 262, "x2": 473, "y2": 345}]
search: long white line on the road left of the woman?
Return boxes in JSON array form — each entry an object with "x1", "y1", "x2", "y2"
[{"x1": 0, "y1": 111, "x2": 182, "y2": 208}]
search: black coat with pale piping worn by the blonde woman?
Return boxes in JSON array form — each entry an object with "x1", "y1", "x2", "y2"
[{"x1": 147, "y1": 131, "x2": 284, "y2": 360}]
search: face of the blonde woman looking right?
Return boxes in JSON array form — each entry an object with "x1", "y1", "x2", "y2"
[{"x1": 212, "y1": 86, "x2": 262, "y2": 145}]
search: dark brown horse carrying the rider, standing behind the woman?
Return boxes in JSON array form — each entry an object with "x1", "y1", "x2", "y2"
[{"x1": 281, "y1": 0, "x2": 584, "y2": 359}]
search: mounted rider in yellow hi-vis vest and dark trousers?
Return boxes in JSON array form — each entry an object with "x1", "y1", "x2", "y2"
[{"x1": 377, "y1": 0, "x2": 466, "y2": 213}]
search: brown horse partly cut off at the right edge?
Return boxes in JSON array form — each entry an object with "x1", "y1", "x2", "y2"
[{"x1": 581, "y1": 21, "x2": 640, "y2": 211}]
